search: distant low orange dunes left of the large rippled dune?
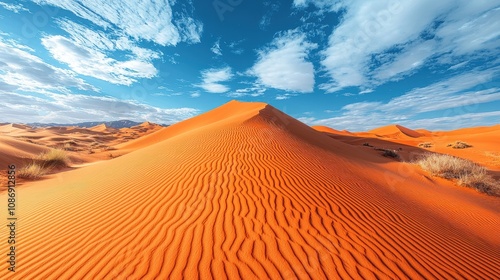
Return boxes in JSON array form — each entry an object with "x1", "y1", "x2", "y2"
[{"x1": 0, "y1": 123, "x2": 162, "y2": 186}]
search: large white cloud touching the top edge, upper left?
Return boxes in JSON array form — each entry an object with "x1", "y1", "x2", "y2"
[{"x1": 33, "y1": 0, "x2": 203, "y2": 46}]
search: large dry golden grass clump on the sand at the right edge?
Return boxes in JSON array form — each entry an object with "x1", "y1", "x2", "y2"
[{"x1": 416, "y1": 153, "x2": 500, "y2": 196}]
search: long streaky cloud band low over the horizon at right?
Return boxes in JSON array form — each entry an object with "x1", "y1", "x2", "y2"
[{"x1": 308, "y1": 69, "x2": 500, "y2": 130}]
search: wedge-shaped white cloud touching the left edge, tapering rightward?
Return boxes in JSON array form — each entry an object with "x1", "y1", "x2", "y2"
[{"x1": 0, "y1": 36, "x2": 98, "y2": 92}]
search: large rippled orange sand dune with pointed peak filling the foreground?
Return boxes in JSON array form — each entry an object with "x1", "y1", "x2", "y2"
[{"x1": 0, "y1": 101, "x2": 500, "y2": 279}]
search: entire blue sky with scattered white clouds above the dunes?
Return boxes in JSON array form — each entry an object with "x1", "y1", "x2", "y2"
[{"x1": 0, "y1": 0, "x2": 500, "y2": 131}]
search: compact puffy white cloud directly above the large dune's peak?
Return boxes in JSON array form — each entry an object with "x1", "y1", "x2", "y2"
[{"x1": 249, "y1": 31, "x2": 317, "y2": 93}]
